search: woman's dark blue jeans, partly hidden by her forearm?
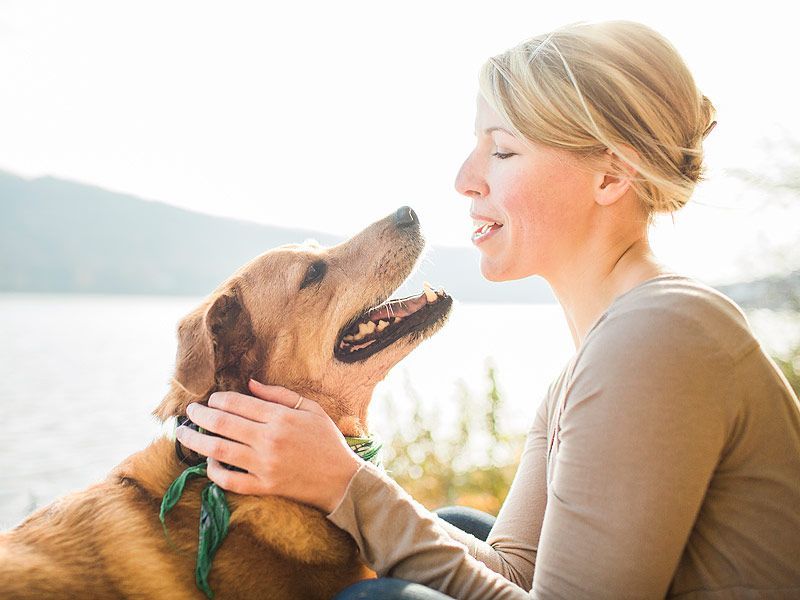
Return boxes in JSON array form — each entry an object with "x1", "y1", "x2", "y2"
[{"x1": 333, "y1": 506, "x2": 494, "y2": 600}]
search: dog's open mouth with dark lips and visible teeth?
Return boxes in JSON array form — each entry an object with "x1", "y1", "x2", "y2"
[{"x1": 333, "y1": 282, "x2": 453, "y2": 362}]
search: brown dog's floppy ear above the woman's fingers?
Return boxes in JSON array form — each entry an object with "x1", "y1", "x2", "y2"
[{"x1": 153, "y1": 285, "x2": 265, "y2": 420}]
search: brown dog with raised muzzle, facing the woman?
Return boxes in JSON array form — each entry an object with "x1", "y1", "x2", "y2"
[{"x1": 0, "y1": 207, "x2": 452, "y2": 600}]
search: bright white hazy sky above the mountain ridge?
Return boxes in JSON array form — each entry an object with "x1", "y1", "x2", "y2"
[{"x1": 0, "y1": 0, "x2": 800, "y2": 283}]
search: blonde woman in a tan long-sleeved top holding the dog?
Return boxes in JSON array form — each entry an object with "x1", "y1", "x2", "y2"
[{"x1": 180, "y1": 21, "x2": 800, "y2": 598}]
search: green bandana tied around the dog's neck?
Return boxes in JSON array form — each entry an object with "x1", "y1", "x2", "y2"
[{"x1": 158, "y1": 436, "x2": 383, "y2": 598}]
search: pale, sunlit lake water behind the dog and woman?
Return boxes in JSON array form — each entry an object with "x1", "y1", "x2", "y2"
[{"x1": 0, "y1": 294, "x2": 800, "y2": 531}]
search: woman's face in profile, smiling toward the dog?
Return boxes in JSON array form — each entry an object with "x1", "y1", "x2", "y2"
[{"x1": 455, "y1": 95, "x2": 593, "y2": 281}]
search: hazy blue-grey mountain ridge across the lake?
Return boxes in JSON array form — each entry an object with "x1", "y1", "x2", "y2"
[{"x1": 0, "y1": 171, "x2": 555, "y2": 303}]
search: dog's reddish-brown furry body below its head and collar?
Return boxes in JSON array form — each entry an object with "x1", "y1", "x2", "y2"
[{"x1": 0, "y1": 440, "x2": 370, "y2": 600}]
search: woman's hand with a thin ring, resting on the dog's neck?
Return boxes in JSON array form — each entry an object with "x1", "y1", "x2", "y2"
[{"x1": 176, "y1": 379, "x2": 362, "y2": 514}]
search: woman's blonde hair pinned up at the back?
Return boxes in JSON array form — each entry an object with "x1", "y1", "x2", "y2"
[{"x1": 479, "y1": 21, "x2": 716, "y2": 224}]
